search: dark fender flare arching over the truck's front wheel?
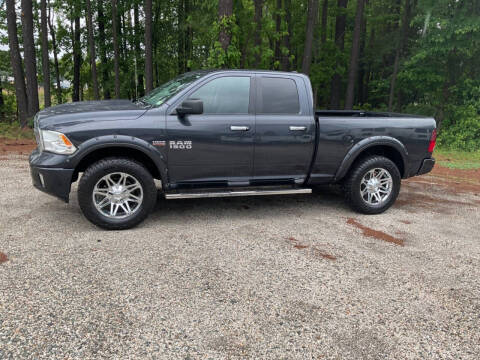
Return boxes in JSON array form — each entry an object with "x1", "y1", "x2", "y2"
[{"x1": 67, "y1": 135, "x2": 168, "y2": 184}]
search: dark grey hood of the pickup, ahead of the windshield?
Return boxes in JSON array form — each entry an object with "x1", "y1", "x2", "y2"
[{"x1": 35, "y1": 100, "x2": 147, "y2": 129}]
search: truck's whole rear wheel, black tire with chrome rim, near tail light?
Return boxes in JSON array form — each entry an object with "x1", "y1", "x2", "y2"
[{"x1": 344, "y1": 156, "x2": 401, "y2": 214}]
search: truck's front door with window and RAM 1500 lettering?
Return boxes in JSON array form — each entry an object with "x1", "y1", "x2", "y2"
[{"x1": 166, "y1": 75, "x2": 255, "y2": 184}]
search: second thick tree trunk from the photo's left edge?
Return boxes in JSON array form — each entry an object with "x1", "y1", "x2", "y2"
[{"x1": 22, "y1": 0, "x2": 39, "y2": 117}]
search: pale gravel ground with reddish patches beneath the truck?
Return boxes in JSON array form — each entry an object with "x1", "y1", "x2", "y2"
[{"x1": 0, "y1": 155, "x2": 480, "y2": 359}]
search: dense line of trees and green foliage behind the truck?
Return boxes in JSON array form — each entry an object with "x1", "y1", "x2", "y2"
[{"x1": 0, "y1": 0, "x2": 480, "y2": 149}]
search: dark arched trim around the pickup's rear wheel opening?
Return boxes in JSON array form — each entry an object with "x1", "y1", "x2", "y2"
[{"x1": 335, "y1": 136, "x2": 408, "y2": 181}]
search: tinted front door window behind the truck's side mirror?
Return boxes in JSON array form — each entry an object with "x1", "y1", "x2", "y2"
[{"x1": 189, "y1": 76, "x2": 250, "y2": 114}]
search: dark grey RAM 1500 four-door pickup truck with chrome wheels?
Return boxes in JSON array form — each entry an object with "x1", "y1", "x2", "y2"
[{"x1": 30, "y1": 70, "x2": 436, "y2": 229}]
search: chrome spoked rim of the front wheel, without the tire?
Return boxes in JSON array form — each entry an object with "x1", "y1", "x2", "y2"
[{"x1": 92, "y1": 172, "x2": 143, "y2": 219}]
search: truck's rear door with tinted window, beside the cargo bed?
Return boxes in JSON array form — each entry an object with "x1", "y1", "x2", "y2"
[{"x1": 254, "y1": 74, "x2": 315, "y2": 183}]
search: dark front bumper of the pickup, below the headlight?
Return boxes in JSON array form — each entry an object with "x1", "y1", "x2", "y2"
[{"x1": 29, "y1": 149, "x2": 74, "y2": 203}]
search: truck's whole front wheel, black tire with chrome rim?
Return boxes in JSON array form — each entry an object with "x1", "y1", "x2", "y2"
[{"x1": 78, "y1": 158, "x2": 157, "y2": 230}]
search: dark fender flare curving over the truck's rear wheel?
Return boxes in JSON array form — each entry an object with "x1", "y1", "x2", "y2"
[{"x1": 335, "y1": 136, "x2": 408, "y2": 181}]
